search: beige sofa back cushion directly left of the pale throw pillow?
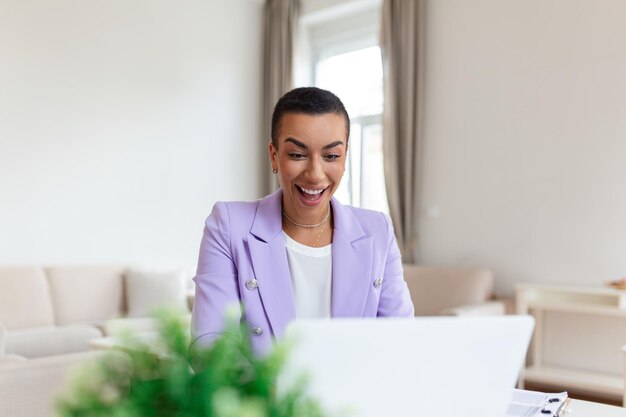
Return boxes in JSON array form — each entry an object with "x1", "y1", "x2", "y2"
[{"x1": 46, "y1": 266, "x2": 124, "y2": 325}]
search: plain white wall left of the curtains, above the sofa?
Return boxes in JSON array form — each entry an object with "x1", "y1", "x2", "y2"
[{"x1": 0, "y1": 0, "x2": 265, "y2": 268}]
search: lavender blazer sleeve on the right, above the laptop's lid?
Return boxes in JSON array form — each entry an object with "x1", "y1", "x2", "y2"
[{"x1": 377, "y1": 213, "x2": 414, "y2": 317}]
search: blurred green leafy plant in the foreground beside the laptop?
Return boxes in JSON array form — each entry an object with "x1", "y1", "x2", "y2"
[{"x1": 57, "y1": 314, "x2": 323, "y2": 417}]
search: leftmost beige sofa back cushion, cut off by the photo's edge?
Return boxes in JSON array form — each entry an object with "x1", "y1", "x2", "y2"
[{"x1": 0, "y1": 267, "x2": 54, "y2": 330}]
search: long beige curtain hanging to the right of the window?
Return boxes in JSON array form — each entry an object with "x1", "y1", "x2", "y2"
[{"x1": 381, "y1": 0, "x2": 424, "y2": 263}]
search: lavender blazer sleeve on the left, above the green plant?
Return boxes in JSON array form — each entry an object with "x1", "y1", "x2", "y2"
[{"x1": 191, "y1": 202, "x2": 241, "y2": 346}]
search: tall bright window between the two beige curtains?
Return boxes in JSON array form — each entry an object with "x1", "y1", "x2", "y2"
[{"x1": 294, "y1": 0, "x2": 389, "y2": 213}]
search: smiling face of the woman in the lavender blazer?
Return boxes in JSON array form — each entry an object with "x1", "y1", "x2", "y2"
[{"x1": 269, "y1": 113, "x2": 348, "y2": 224}]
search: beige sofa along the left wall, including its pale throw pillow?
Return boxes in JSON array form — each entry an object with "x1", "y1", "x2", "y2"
[{"x1": 0, "y1": 266, "x2": 190, "y2": 358}]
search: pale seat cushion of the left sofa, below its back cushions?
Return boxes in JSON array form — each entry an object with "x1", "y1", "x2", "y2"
[{"x1": 6, "y1": 325, "x2": 102, "y2": 358}]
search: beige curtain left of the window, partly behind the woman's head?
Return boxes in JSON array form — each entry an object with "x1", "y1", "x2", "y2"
[{"x1": 262, "y1": 0, "x2": 299, "y2": 194}]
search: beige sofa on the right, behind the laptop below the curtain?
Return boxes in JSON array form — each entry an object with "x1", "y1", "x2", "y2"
[{"x1": 404, "y1": 264, "x2": 508, "y2": 316}]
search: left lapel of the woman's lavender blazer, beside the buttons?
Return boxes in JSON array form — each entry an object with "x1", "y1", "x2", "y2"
[{"x1": 248, "y1": 190, "x2": 296, "y2": 338}]
